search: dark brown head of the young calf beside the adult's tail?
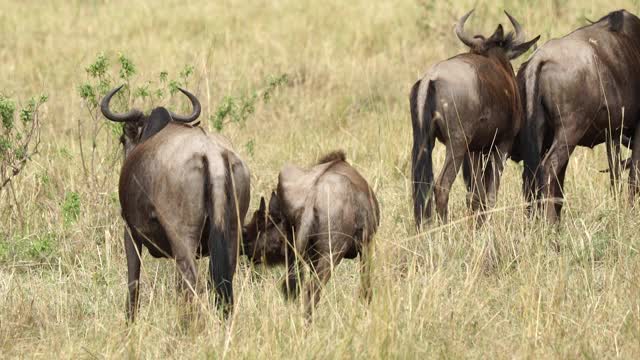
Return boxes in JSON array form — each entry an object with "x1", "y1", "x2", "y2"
[{"x1": 242, "y1": 192, "x2": 289, "y2": 265}]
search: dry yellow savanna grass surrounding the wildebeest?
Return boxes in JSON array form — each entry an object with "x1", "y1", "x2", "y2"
[{"x1": 0, "y1": 0, "x2": 640, "y2": 358}]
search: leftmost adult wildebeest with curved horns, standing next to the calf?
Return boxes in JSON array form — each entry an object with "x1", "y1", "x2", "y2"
[{"x1": 101, "y1": 86, "x2": 250, "y2": 321}]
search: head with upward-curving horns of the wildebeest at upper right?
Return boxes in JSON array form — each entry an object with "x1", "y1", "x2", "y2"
[{"x1": 455, "y1": 10, "x2": 540, "y2": 60}]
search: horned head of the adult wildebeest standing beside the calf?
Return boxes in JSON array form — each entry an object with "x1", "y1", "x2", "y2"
[{"x1": 100, "y1": 85, "x2": 201, "y2": 156}]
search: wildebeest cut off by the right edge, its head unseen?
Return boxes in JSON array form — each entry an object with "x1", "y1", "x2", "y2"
[{"x1": 518, "y1": 10, "x2": 640, "y2": 222}]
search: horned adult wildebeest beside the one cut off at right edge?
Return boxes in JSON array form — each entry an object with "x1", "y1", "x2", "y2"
[{"x1": 410, "y1": 10, "x2": 539, "y2": 227}]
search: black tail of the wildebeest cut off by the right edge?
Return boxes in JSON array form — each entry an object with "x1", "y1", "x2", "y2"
[{"x1": 515, "y1": 58, "x2": 546, "y2": 201}]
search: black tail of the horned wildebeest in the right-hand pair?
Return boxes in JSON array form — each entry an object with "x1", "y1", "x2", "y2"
[{"x1": 409, "y1": 80, "x2": 436, "y2": 227}]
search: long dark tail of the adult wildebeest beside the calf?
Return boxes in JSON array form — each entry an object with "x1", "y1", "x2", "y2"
[{"x1": 204, "y1": 154, "x2": 235, "y2": 314}]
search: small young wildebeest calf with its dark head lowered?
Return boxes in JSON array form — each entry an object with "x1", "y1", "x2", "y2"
[{"x1": 244, "y1": 152, "x2": 380, "y2": 319}]
